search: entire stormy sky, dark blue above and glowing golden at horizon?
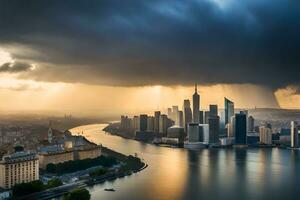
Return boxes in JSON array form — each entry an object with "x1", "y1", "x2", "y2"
[{"x1": 0, "y1": 0, "x2": 300, "y2": 114}]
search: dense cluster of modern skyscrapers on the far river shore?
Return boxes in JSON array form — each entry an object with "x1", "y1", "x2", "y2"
[{"x1": 115, "y1": 85, "x2": 298, "y2": 148}]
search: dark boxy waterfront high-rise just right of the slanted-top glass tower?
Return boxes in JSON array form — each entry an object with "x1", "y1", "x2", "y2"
[{"x1": 235, "y1": 112, "x2": 247, "y2": 145}]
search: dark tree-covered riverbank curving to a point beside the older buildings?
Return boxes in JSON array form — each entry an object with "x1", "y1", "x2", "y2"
[{"x1": 13, "y1": 126, "x2": 148, "y2": 200}]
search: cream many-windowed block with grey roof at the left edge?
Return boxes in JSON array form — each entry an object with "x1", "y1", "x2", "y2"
[{"x1": 0, "y1": 151, "x2": 39, "y2": 189}]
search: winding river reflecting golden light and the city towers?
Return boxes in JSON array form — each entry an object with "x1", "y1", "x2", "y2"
[{"x1": 71, "y1": 124, "x2": 300, "y2": 200}]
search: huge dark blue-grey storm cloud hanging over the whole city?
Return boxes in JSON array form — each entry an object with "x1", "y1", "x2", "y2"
[{"x1": 0, "y1": 0, "x2": 300, "y2": 88}]
